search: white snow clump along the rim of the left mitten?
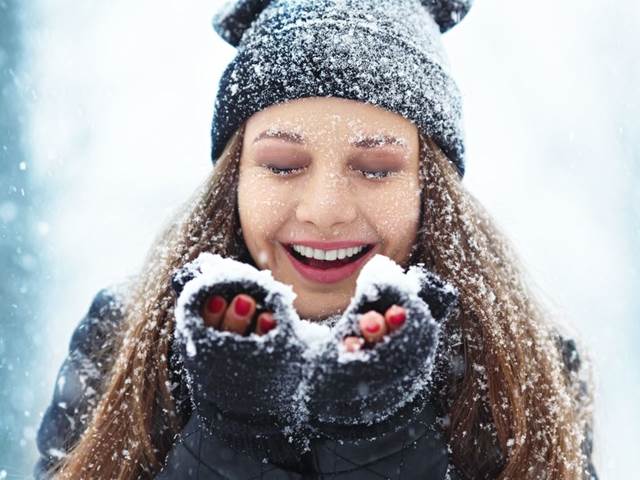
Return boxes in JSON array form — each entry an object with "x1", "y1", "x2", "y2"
[{"x1": 175, "y1": 252, "x2": 297, "y2": 357}]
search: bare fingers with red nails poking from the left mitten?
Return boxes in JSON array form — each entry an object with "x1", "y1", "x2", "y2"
[{"x1": 202, "y1": 293, "x2": 276, "y2": 335}]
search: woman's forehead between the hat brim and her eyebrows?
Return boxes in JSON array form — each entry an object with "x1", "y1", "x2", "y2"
[{"x1": 245, "y1": 97, "x2": 417, "y2": 147}]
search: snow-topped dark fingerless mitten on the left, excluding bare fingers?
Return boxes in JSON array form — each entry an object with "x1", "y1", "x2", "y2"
[{"x1": 172, "y1": 252, "x2": 304, "y2": 455}]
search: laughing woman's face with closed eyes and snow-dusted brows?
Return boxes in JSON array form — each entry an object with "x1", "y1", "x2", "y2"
[{"x1": 238, "y1": 97, "x2": 420, "y2": 320}]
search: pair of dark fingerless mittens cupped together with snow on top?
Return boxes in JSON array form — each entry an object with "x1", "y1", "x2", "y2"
[{"x1": 172, "y1": 252, "x2": 457, "y2": 440}]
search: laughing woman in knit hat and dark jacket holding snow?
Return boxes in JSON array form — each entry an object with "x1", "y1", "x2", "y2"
[{"x1": 36, "y1": 0, "x2": 595, "y2": 479}]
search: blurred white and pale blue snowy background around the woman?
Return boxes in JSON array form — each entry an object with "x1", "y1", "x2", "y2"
[{"x1": 0, "y1": 0, "x2": 640, "y2": 479}]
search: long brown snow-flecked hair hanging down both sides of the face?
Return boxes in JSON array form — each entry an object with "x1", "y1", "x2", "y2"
[{"x1": 56, "y1": 123, "x2": 591, "y2": 479}]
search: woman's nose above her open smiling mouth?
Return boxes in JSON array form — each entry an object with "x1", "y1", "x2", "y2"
[{"x1": 296, "y1": 170, "x2": 357, "y2": 233}]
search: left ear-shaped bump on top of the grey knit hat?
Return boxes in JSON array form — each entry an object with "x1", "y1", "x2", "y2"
[{"x1": 212, "y1": 0, "x2": 271, "y2": 47}]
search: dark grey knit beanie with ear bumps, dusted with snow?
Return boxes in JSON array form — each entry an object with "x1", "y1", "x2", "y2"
[{"x1": 211, "y1": 0, "x2": 473, "y2": 178}]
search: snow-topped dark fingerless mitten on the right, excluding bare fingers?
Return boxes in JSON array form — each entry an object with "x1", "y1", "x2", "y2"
[{"x1": 303, "y1": 255, "x2": 457, "y2": 433}]
